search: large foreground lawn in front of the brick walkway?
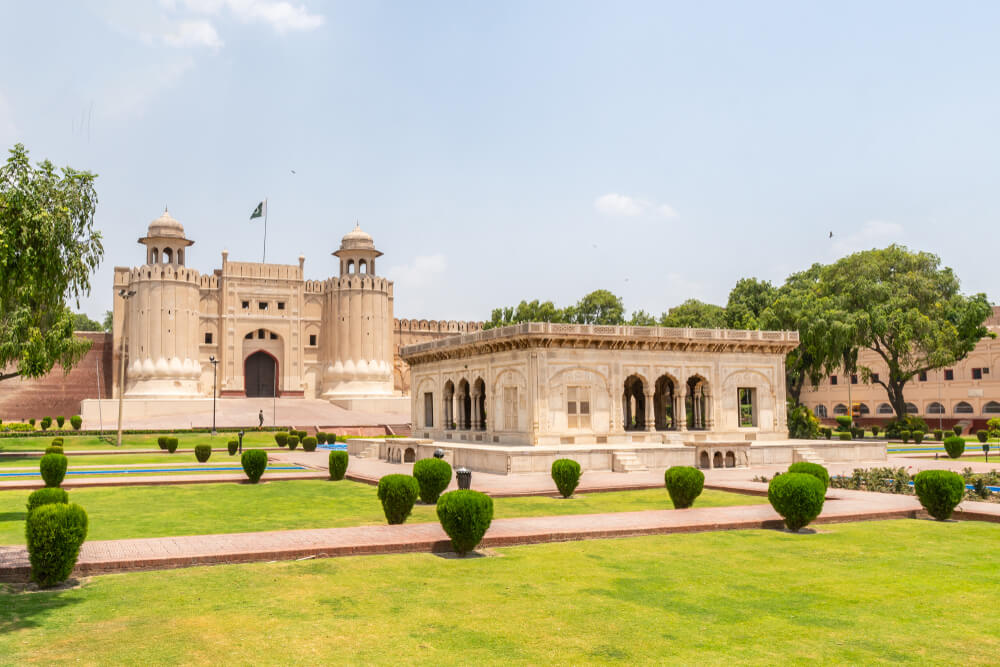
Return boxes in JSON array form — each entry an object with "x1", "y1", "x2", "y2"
[{"x1": 0, "y1": 520, "x2": 1000, "y2": 665}]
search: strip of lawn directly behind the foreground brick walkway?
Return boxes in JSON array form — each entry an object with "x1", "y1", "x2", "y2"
[{"x1": 0, "y1": 482, "x2": 767, "y2": 544}]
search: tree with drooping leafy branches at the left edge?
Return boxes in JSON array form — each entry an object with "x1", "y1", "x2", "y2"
[{"x1": 0, "y1": 144, "x2": 104, "y2": 380}]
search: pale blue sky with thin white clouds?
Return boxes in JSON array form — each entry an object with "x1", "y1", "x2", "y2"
[{"x1": 0, "y1": 0, "x2": 1000, "y2": 320}]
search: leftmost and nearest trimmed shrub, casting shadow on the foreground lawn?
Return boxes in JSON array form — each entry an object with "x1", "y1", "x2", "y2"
[{"x1": 24, "y1": 503, "x2": 87, "y2": 588}]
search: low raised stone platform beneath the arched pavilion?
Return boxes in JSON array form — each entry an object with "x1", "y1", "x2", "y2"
[{"x1": 347, "y1": 438, "x2": 886, "y2": 475}]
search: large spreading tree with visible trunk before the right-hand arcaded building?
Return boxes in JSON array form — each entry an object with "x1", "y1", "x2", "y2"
[{"x1": 821, "y1": 245, "x2": 992, "y2": 419}]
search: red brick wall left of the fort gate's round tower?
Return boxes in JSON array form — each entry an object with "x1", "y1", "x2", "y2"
[{"x1": 0, "y1": 331, "x2": 112, "y2": 428}]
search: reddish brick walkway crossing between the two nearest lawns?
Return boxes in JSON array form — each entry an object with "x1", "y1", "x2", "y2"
[{"x1": 0, "y1": 482, "x2": 1000, "y2": 581}]
